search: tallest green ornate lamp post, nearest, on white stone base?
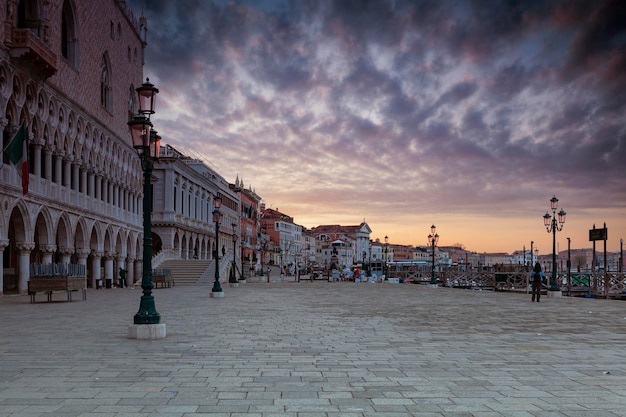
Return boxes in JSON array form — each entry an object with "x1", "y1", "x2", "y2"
[{"x1": 123, "y1": 79, "x2": 165, "y2": 339}]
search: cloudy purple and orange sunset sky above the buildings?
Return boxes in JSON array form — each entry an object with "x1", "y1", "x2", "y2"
[{"x1": 128, "y1": 0, "x2": 626, "y2": 254}]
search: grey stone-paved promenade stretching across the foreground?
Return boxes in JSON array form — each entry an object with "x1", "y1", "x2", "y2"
[{"x1": 0, "y1": 281, "x2": 626, "y2": 417}]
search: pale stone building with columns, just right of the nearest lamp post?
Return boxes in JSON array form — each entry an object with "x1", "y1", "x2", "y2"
[{"x1": 152, "y1": 145, "x2": 240, "y2": 268}]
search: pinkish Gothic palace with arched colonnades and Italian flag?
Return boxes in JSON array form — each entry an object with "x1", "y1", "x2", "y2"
[{"x1": 0, "y1": 0, "x2": 147, "y2": 294}]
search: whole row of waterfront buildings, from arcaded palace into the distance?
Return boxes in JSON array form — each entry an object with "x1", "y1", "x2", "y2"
[{"x1": 0, "y1": 0, "x2": 620, "y2": 294}]
